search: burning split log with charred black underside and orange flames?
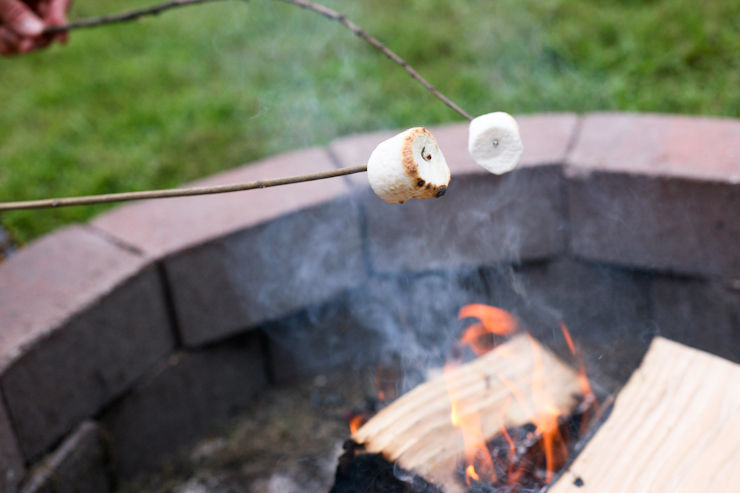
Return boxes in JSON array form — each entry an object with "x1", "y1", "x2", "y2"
[{"x1": 332, "y1": 332, "x2": 583, "y2": 493}]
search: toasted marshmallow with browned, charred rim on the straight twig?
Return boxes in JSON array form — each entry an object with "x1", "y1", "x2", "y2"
[{"x1": 367, "y1": 127, "x2": 450, "y2": 204}]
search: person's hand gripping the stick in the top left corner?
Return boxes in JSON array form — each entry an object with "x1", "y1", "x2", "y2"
[{"x1": 0, "y1": 0, "x2": 72, "y2": 55}]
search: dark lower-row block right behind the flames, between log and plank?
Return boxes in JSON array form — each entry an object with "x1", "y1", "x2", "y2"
[{"x1": 520, "y1": 259, "x2": 656, "y2": 391}]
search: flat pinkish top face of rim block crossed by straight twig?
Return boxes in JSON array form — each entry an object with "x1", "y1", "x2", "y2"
[{"x1": 92, "y1": 148, "x2": 356, "y2": 257}]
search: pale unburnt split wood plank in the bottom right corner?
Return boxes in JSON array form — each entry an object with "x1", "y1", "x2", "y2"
[{"x1": 550, "y1": 337, "x2": 740, "y2": 493}]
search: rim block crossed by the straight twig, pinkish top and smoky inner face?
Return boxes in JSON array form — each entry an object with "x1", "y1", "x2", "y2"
[{"x1": 93, "y1": 149, "x2": 365, "y2": 346}]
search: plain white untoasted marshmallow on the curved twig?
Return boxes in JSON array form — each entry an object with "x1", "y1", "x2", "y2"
[{"x1": 468, "y1": 111, "x2": 524, "y2": 175}]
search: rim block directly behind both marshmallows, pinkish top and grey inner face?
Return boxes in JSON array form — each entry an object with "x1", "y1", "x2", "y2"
[{"x1": 330, "y1": 114, "x2": 578, "y2": 273}]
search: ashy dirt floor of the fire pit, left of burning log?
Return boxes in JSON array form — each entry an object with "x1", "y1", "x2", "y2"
[{"x1": 118, "y1": 372, "x2": 374, "y2": 493}]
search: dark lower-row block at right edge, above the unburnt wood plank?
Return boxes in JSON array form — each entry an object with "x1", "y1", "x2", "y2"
[{"x1": 650, "y1": 276, "x2": 740, "y2": 362}]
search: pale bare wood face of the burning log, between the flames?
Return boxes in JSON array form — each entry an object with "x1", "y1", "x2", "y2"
[{"x1": 352, "y1": 335, "x2": 580, "y2": 493}]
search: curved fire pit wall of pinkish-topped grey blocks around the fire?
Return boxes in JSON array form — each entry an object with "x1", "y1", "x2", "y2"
[{"x1": 0, "y1": 113, "x2": 740, "y2": 492}]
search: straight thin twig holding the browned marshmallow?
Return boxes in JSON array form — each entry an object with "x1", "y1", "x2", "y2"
[{"x1": 0, "y1": 164, "x2": 367, "y2": 212}]
